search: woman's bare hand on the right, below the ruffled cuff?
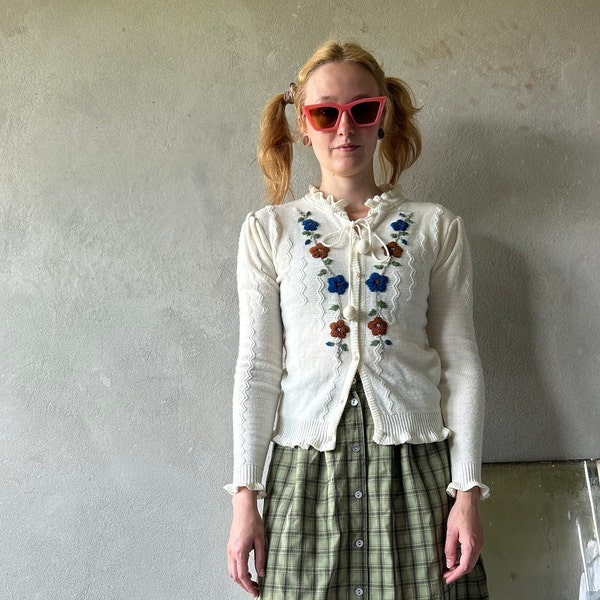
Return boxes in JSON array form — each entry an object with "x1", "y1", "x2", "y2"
[{"x1": 443, "y1": 487, "x2": 483, "y2": 584}]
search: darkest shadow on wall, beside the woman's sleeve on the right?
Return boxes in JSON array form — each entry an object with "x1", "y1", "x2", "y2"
[{"x1": 471, "y1": 236, "x2": 565, "y2": 462}]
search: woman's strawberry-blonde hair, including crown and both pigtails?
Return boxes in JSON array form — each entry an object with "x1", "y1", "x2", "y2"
[{"x1": 258, "y1": 40, "x2": 421, "y2": 204}]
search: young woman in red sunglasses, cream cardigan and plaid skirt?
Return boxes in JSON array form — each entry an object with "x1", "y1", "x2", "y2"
[{"x1": 226, "y1": 42, "x2": 488, "y2": 600}]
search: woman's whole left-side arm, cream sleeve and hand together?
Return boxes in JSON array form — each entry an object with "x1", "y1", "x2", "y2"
[{"x1": 226, "y1": 215, "x2": 283, "y2": 597}]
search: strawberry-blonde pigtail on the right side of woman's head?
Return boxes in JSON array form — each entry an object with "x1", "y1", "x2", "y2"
[{"x1": 379, "y1": 77, "x2": 421, "y2": 186}]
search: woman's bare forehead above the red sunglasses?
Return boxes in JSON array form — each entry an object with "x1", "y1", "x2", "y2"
[{"x1": 305, "y1": 62, "x2": 379, "y2": 104}]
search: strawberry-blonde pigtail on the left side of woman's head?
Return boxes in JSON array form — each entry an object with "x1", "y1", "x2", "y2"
[{"x1": 258, "y1": 94, "x2": 294, "y2": 204}]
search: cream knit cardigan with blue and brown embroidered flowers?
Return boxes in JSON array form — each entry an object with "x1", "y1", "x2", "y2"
[{"x1": 225, "y1": 188, "x2": 489, "y2": 497}]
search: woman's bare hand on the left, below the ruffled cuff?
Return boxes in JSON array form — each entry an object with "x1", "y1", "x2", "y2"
[{"x1": 227, "y1": 488, "x2": 265, "y2": 598}]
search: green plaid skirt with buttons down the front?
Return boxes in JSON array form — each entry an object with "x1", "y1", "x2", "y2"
[{"x1": 259, "y1": 381, "x2": 488, "y2": 600}]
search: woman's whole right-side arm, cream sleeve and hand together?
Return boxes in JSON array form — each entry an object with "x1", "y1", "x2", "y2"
[{"x1": 427, "y1": 211, "x2": 489, "y2": 584}]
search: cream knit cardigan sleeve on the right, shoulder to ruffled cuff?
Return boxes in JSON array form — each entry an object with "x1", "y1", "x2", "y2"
[{"x1": 427, "y1": 211, "x2": 489, "y2": 498}]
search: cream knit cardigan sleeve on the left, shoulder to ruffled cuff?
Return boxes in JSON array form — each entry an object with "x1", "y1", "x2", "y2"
[{"x1": 225, "y1": 214, "x2": 283, "y2": 497}]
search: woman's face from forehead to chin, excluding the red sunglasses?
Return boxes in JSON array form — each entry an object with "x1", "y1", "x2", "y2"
[{"x1": 300, "y1": 62, "x2": 381, "y2": 185}]
